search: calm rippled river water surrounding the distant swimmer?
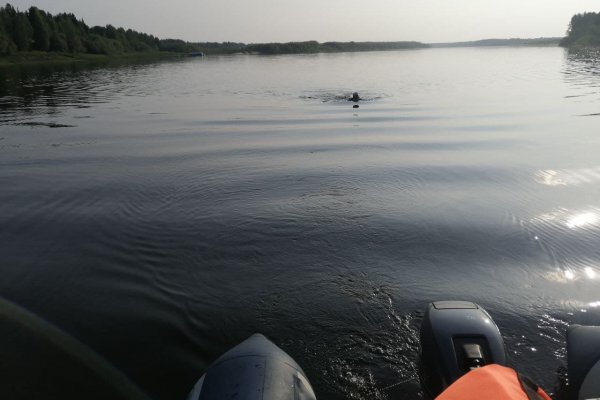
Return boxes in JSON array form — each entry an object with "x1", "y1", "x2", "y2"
[{"x1": 0, "y1": 48, "x2": 600, "y2": 399}]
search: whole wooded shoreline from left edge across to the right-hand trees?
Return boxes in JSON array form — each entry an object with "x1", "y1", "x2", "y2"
[{"x1": 0, "y1": 4, "x2": 568, "y2": 66}]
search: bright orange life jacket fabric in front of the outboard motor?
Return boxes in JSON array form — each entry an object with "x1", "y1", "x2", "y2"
[{"x1": 435, "y1": 364, "x2": 551, "y2": 400}]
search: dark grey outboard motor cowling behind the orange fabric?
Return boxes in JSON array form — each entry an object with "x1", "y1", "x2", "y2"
[{"x1": 419, "y1": 301, "x2": 506, "y2": 398}]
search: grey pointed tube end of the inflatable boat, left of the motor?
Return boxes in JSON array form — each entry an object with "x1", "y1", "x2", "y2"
[{"x1": 188, "y1": 333, "x2": 316, "y2": 400}]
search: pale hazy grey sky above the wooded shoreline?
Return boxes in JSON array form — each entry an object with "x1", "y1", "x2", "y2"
[{"x1": 9, "y1": 0, "x2": 600, "y2": 43}]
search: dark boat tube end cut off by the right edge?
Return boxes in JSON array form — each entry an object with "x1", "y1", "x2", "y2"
[{"x1": 567, "y1": 325, "x2": 600, "y2": 400}]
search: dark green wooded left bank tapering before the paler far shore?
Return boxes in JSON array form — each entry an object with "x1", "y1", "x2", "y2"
[{"x1": 0, "y1": 4, "x2": 427, "y2": 56}]
